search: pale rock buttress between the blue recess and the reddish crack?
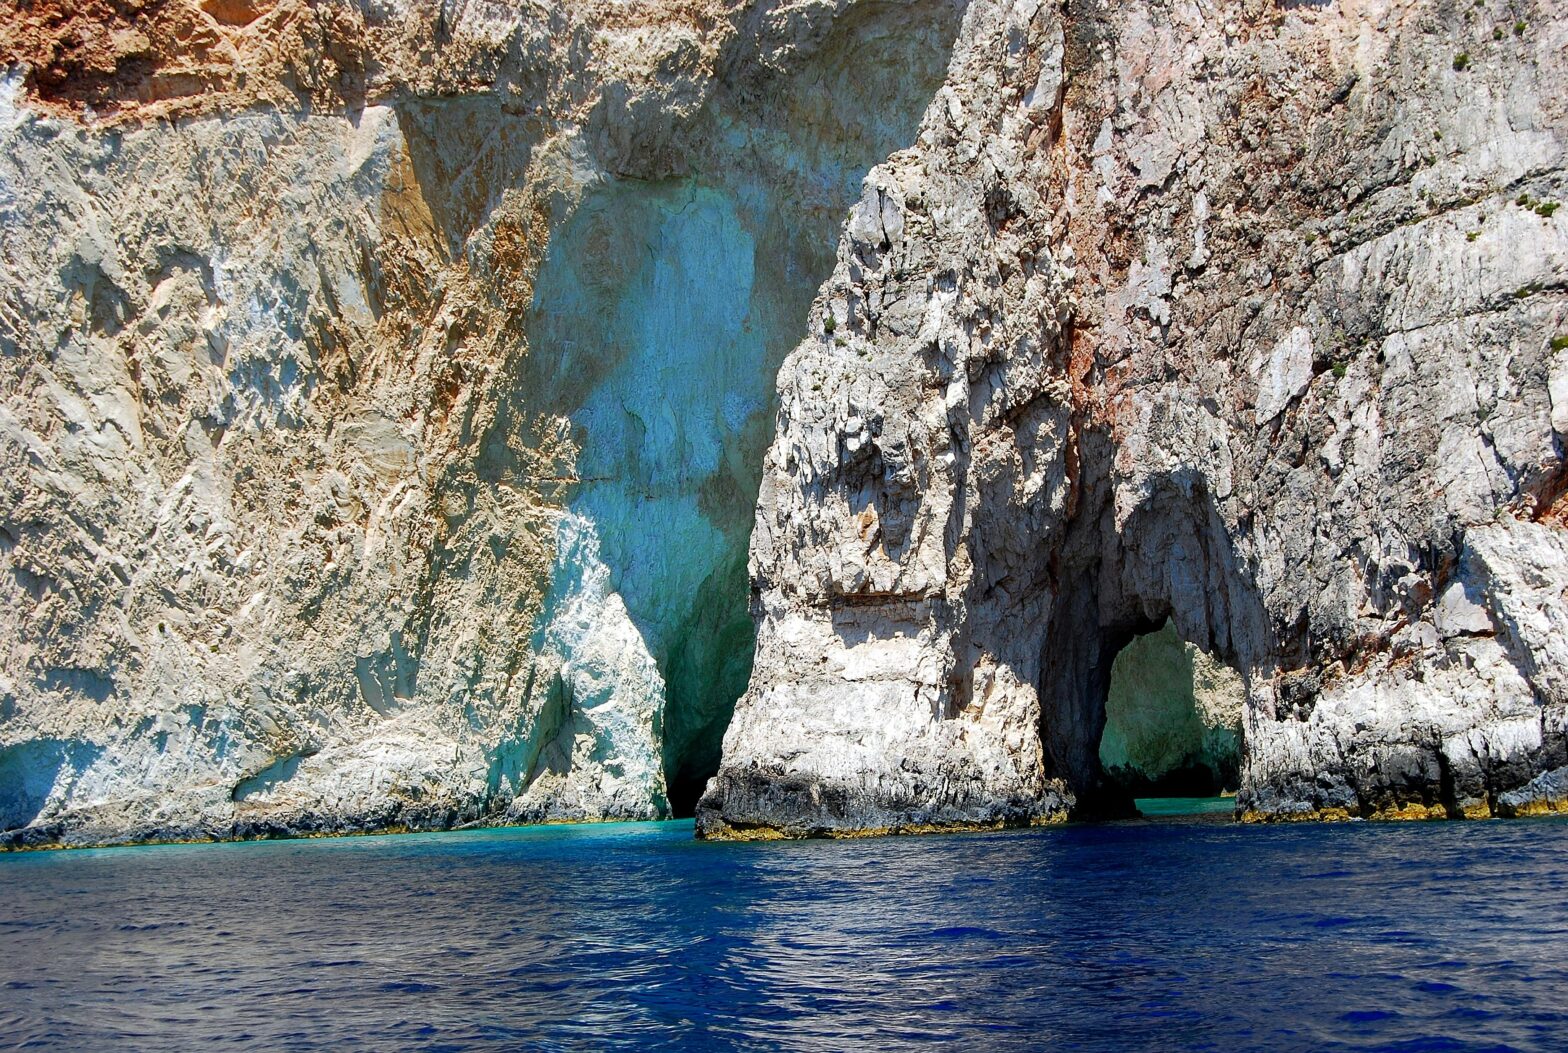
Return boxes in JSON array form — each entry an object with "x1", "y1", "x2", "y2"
[{"x1": 698, "y1": 5, "x2": 1069, "y2": 837}]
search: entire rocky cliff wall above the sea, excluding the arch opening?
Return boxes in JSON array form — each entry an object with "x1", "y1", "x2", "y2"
[{"x1": 0, "y1": 0, "x2": 1568, "y2": 845}]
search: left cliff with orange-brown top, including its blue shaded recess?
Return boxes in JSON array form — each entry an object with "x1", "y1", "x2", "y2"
[{"x1": 0, "y1": 0, "x2": 958, "y2": 845}]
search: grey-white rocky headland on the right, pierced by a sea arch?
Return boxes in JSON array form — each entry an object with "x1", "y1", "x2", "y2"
[{"x1": 698, "y1": 0, "x2": 1568, "y2": 837}]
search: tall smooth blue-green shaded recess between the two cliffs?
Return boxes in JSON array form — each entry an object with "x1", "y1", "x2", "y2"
[{"x1": 501, "y1": 0, "x2": 964, "y2": 815}]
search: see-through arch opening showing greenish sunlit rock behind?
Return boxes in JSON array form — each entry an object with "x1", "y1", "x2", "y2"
[{"x1": 1099, "y1": 621, "x2": 1247, "y2": 813}]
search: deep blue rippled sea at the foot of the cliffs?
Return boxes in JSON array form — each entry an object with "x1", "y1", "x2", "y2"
[{"x1": 0, "y1": 818, "x2": 1568, "y2": 1053}]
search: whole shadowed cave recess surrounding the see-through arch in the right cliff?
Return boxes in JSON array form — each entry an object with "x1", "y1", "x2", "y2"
[{"x1": 1038, "y1": 451, "x2": 1272, "y2": 820}]
